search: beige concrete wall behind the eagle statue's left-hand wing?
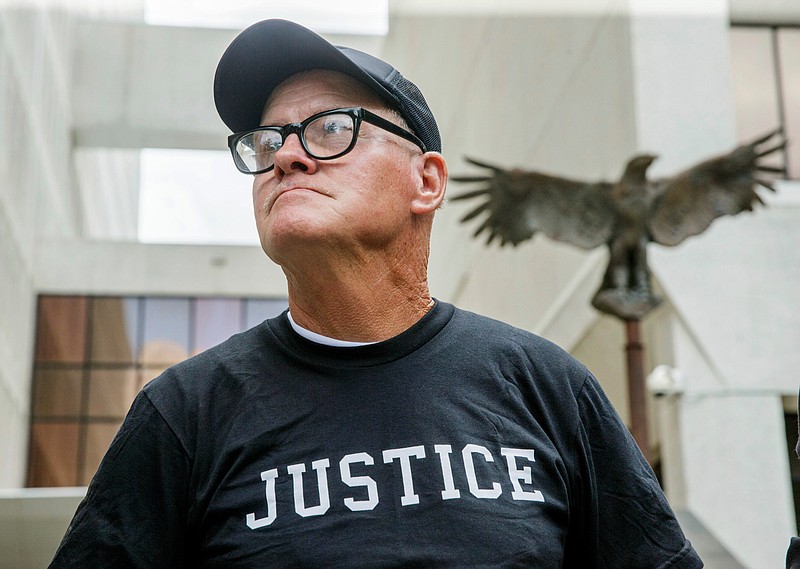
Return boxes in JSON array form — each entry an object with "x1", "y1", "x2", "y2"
[{"x1": 385, "y1": 4, "x2": 635, "y2": 330}]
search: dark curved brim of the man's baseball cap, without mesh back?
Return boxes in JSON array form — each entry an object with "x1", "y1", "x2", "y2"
[{"x1": 214, "y1": 20, "x2": 395, "y2": 132}]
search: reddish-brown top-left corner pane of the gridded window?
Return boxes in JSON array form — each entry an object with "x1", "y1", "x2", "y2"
[{"x1": 36, "y1": 296, "x2": 87, "y2": 363}]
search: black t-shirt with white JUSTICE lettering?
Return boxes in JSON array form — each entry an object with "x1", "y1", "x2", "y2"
[{"x1": 51, "y1": 302, "x2": 702, "y2": 569}]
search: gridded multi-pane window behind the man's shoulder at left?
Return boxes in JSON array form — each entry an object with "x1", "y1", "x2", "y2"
[{"x1": 28, "y1": 296, "x2": 287, "y2": 486}]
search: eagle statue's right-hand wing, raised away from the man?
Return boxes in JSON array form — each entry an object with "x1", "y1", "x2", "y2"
[{"x1": 648, "y1": 130, "x2": 786, "y2": 246}]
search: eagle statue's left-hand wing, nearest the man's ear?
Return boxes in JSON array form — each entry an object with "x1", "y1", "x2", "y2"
[{"x1": 451, "y1": 158, "x2": 618, "y2": 249}]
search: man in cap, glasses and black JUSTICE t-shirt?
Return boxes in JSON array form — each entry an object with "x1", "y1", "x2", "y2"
[{"x1": 52, "y1": 20, "x2": 702, "y2": 569}]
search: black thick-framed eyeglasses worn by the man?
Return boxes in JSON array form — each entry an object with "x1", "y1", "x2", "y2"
[{"x1": 228, "y1": 107, "x2": 426, "y2": 174}]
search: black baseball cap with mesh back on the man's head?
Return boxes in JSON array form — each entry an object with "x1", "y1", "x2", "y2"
[{"x1": 214, "y1": 20, "x2": 442, "y2": 152}]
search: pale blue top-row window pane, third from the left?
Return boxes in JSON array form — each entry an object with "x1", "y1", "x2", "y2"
[{"x1": 141, "y1": 298, "x2": 189, "y2": 365}]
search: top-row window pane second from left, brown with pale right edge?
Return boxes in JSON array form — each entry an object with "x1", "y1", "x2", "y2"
[{"x1": 91, "y1": 298, "x2": 138, "y2": 363}]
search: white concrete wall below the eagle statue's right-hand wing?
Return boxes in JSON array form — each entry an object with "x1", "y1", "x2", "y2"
[{"x1": 655, "y1": 196, "x2": 800, "y2": 568}]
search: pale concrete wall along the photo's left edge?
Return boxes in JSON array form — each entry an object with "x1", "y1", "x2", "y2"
[{"x1": 0, "y1": 9, "x2": 80, "y2": 487}]
